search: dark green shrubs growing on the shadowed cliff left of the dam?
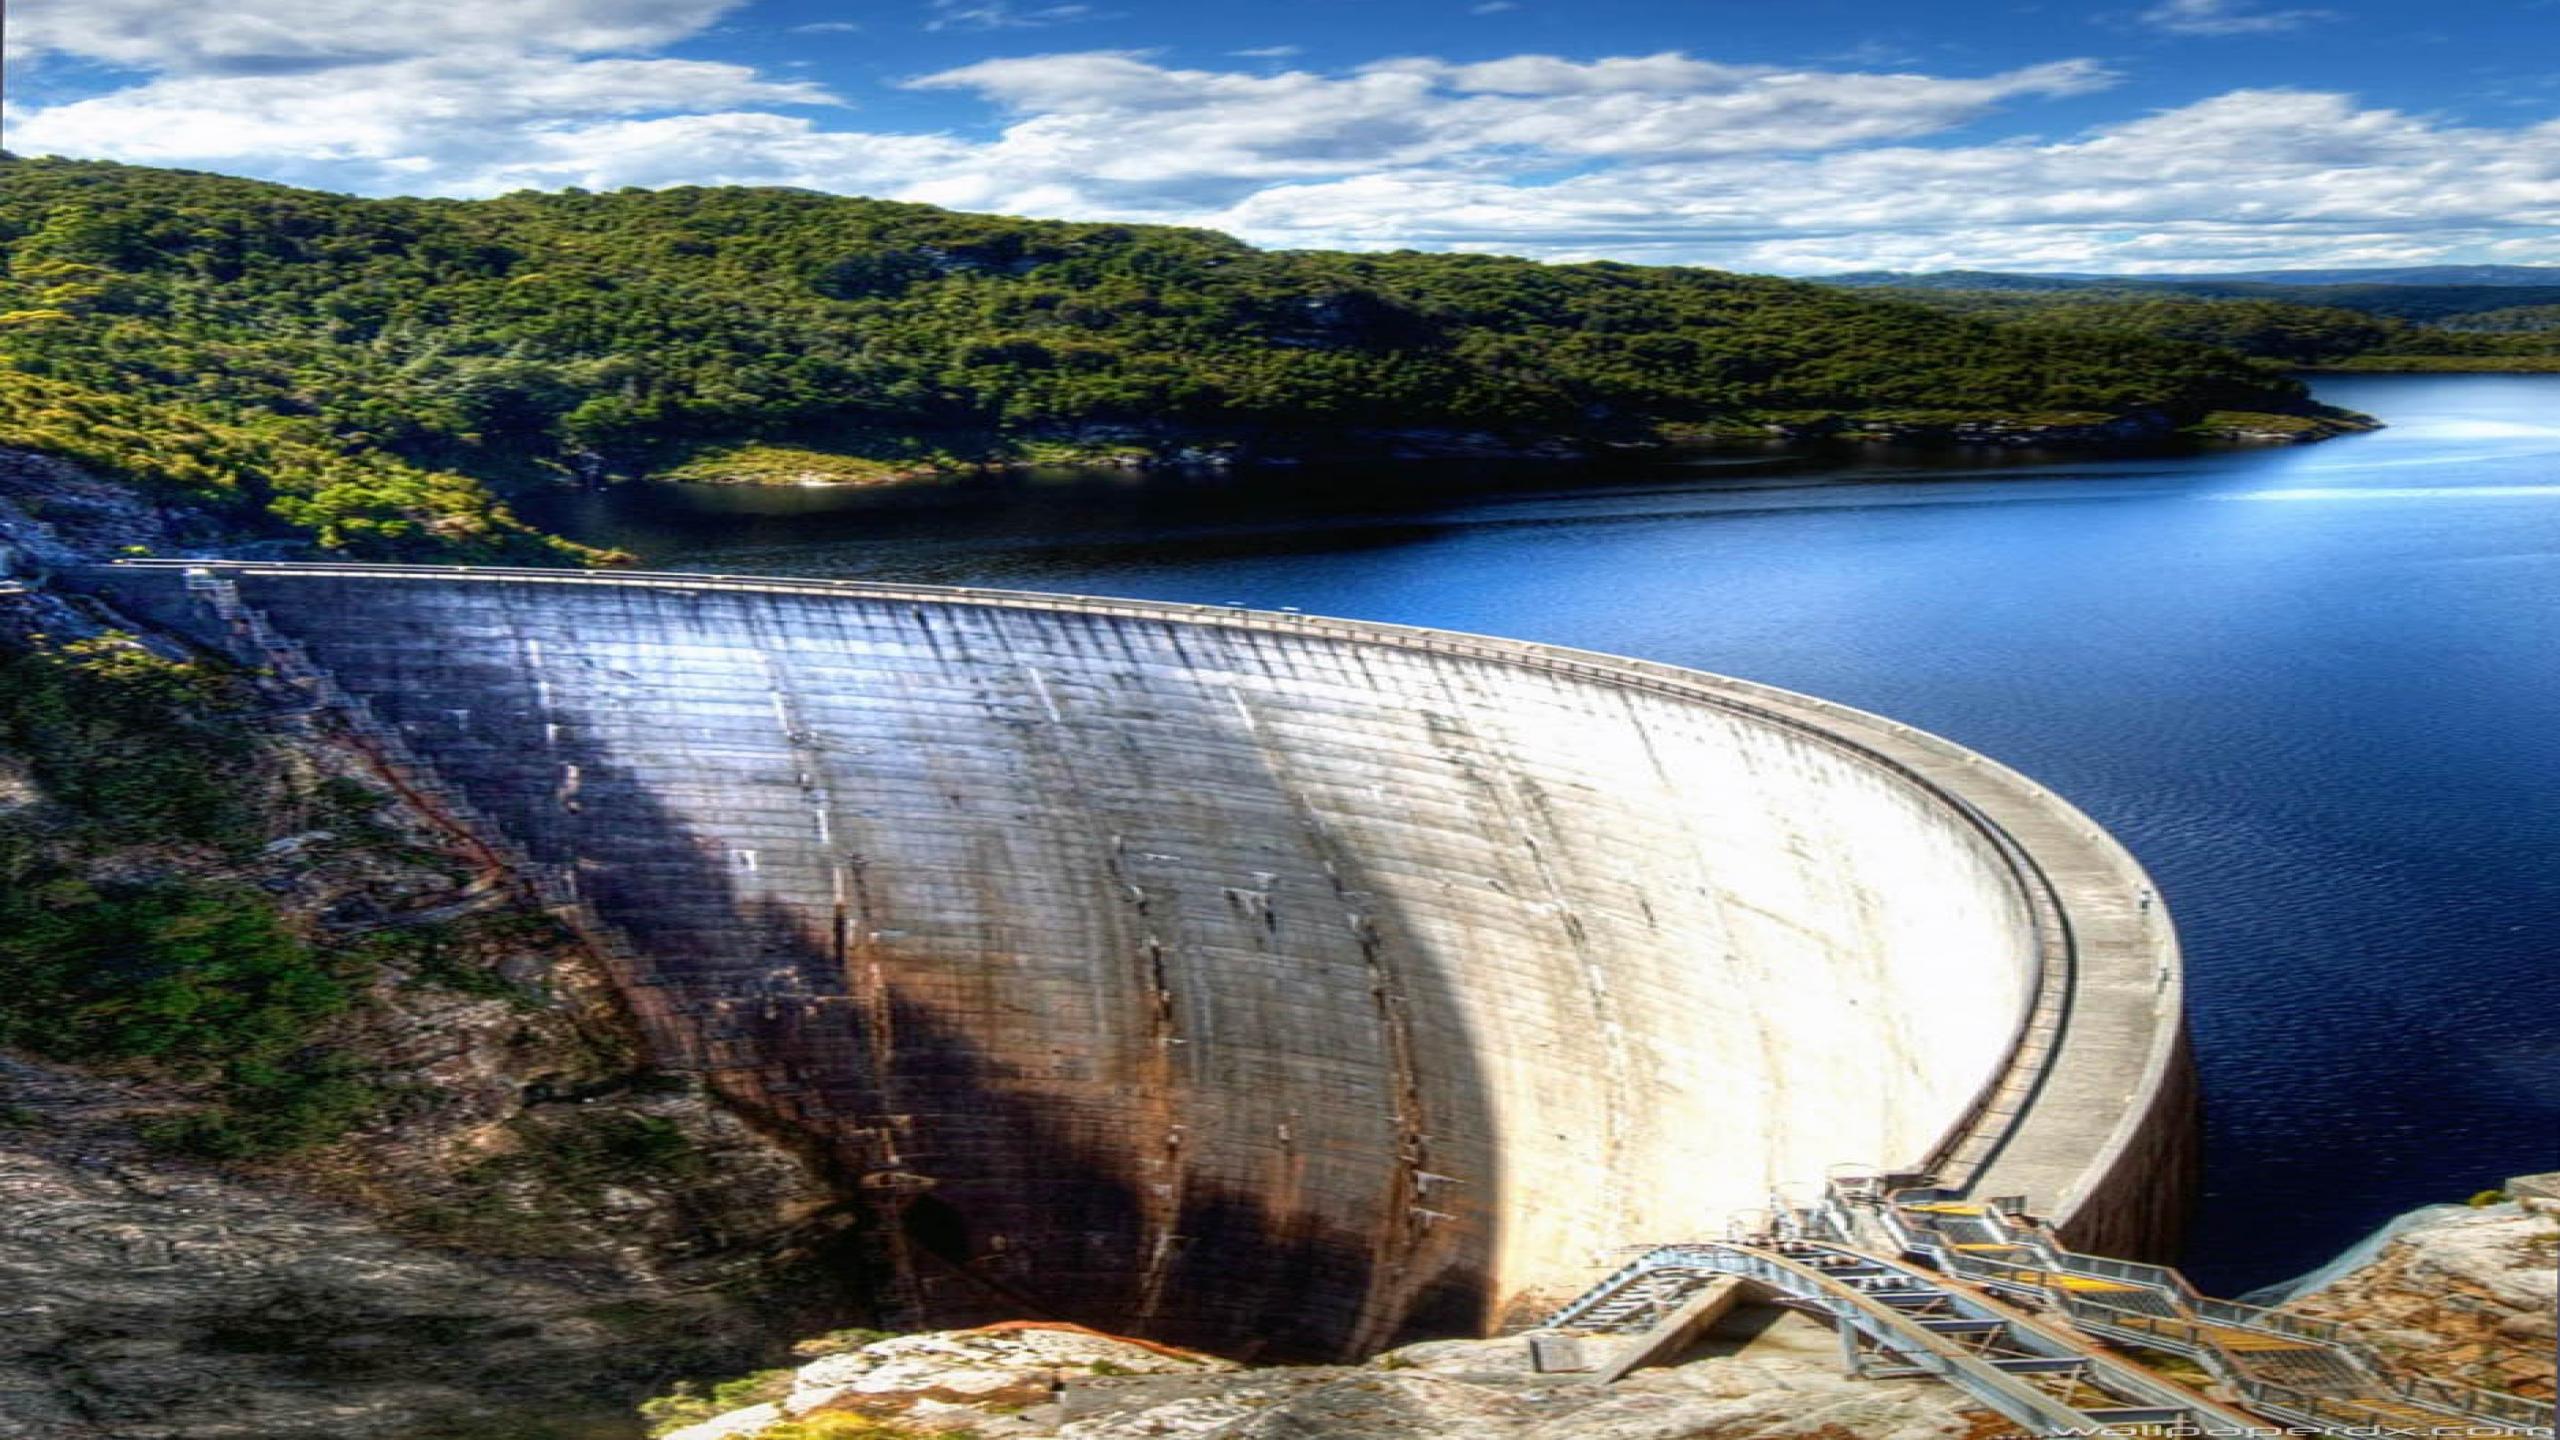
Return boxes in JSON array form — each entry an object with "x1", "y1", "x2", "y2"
[{"x1": 0, "y1": 635, "x2": 376, "y2": 1158}]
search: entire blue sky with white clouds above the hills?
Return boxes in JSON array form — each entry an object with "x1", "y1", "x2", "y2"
[{"x1": 5, "y1": 0, "x2": 2560, "y2": 274}]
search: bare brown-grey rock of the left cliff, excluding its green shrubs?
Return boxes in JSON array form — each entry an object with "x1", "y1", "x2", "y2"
[{"x1": 0, "y1": 515, "x2": 847, "y2": 1440}]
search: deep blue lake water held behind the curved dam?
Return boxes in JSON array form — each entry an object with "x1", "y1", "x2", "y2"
[{"x1": 538, "y1": 377, "x2": 2560, "y2": 1291}]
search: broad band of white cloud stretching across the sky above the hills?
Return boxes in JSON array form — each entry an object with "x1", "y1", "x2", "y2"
[{"x1": 10, "y1": 23, "x2": 2560, "y2": 272}]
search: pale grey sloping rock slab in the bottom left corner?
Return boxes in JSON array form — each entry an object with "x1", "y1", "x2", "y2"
[{"x1": 0, "y1": 1063, "x2": 701, "y2": 1440}]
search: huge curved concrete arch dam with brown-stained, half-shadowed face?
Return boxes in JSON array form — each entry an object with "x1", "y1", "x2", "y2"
[{"x1": 90, "y1": 564, "x2": 2189, "y2": 1355}]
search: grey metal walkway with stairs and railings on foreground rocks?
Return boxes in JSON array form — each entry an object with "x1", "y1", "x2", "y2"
[{"x1": 1546, "y1": 1181, "x2": 2552, "y2": 1435}]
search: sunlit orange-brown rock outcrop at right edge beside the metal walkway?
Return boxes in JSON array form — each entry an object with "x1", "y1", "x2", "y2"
[{"x1": 2284, "y1": 1204, "x2": 2560, "y2": 1399}]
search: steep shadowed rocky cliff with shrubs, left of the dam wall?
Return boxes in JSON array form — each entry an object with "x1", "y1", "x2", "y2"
[{"x1": 0, "y1": 456, "x2": 855, "y2": 1440}]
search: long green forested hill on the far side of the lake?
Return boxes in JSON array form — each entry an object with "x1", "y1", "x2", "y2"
[{"x1": 0, "y1": 159, "x2": 2344, "y2": 553}]
